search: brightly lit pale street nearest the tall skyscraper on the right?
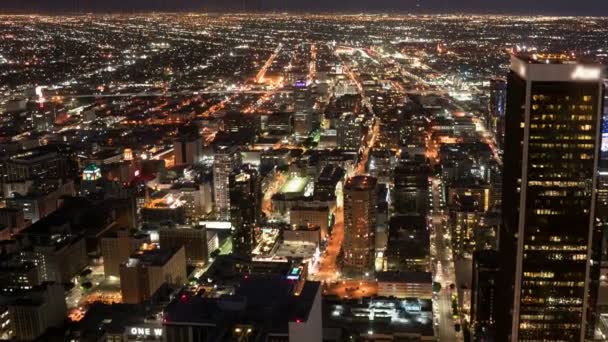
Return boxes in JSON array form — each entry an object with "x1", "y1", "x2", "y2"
[{"x1": 431, "y1": 179, "x2": 463, "y2": 341}]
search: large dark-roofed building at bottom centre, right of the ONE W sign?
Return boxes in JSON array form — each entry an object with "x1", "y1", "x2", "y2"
[{"x1": 163, "y1": 275, "x2": 323, "y2": 342}]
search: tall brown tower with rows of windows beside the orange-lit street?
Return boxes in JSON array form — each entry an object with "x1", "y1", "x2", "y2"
[{"x1": 343, "y1": 176, "x2": 377, "y2": 274}]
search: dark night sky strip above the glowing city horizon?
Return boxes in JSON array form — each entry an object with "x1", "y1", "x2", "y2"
[{"x1": 0, "y1": 0, "x2": 608, "y2": 15}]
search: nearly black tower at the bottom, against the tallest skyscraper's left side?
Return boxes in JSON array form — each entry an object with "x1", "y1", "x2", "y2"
[{"x1": 471, "y1": 250, "x2": 502, "y2": 342}]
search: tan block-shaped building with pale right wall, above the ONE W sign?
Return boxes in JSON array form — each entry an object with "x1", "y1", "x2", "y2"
[{"x1": 120, "y1": 247, "x2": 187, "y2": 304}]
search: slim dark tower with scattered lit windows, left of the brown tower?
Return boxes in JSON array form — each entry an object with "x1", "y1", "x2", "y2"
[{"x1": 230, "y1": 167, "x2": 262, "y2": 256}]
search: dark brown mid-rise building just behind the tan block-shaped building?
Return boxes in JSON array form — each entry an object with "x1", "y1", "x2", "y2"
[{"x1": 158, "y1": 225, "x2": 209, "y2": 265}]
